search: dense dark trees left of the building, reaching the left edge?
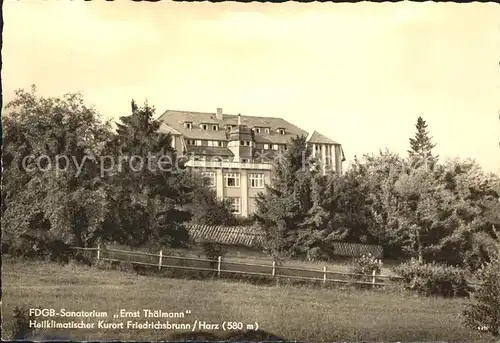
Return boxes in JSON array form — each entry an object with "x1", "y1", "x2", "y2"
[{"x1": 2, "y1": 87, "x2": 236, "y2": 255}]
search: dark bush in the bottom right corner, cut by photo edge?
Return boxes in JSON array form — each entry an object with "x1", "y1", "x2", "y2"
[{"x1": 463, "y1": 259, "x2": 500, "y2": 337}]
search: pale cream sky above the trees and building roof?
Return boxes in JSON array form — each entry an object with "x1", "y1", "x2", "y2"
[{"x1": 2, "y1": 0, "x2": 500, "y2": 173}]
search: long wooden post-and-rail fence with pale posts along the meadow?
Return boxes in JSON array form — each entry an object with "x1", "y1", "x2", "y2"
[{"x1": 74, "y1": 246, "x2": 402, "y2": 288}]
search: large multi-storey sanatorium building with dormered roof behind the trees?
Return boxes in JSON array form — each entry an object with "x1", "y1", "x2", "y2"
[{"x1": 158, "y1": 108, "x2": 345, "y2": 217}]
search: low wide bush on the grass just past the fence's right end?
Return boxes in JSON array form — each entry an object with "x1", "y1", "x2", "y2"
[{"x1": 394, "y1": 259, "x2": 470, "y2": 297}]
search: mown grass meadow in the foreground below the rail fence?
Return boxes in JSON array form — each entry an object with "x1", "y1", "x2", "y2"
[{"x1": 2, "y1": 259, "x2": 493, "y2": 342}]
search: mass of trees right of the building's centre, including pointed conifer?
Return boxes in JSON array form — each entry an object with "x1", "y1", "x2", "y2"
[{"x1": 256, "y1": 118, "x2": 500, "y2": 269}]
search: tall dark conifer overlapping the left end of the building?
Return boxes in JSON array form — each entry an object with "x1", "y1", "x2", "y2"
[{"x1": 106, "y1": 101, "x2": 190, "y2": 245}]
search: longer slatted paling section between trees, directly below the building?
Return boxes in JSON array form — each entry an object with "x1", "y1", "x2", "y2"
[{"x1": 187, "y1": 224, "x2": 264, "y2": 247}]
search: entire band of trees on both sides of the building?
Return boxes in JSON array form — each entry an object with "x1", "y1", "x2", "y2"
[{"x1": 2, "y1": 85, "x2": 500, "y2": 269}]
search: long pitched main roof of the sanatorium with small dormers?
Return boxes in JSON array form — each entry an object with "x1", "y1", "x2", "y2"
[{"x1": 158, "y1": 110, "x2": 307, "y2": 144}]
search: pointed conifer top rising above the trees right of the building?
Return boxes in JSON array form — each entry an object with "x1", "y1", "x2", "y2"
[{"x1": 408, "y1": 117, "x2": 439, "y2": 170}]
